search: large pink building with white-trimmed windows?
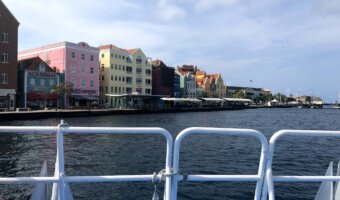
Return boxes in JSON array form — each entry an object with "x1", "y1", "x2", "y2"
[{"x1": 18, "y1": 42, "x2": 99, "y2": 106}]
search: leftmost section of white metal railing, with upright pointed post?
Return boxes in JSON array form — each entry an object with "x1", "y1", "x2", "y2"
[{"x1": 0, "y1": 120, "x2": 173, "y2": 200}]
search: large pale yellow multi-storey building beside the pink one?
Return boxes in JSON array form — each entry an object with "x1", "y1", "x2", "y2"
[{"x1": 99, "y1": 44, "x2": 152, "y2": 107}]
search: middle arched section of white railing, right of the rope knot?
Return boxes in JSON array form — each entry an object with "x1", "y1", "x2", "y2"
[{"x1": 171, "y1": 127, "x2": 268, "y2": 200}]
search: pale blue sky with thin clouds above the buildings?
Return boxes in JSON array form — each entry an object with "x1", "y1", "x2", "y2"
[{"x1": 3, "y1": 0, "x2": 340, "y2": 102}]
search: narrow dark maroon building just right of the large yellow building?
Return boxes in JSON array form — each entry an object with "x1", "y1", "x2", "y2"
[{"x1": 152, "y1": 60, "x2": 175, "y2": 97}]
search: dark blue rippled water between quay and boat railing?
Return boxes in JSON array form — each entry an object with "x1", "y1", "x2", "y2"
[{"x1": 0, "y1": 109, "x2": 340, "y2": 200}]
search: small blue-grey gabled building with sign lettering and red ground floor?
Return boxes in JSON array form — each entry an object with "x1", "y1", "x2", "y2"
[{"x1": 17, "y1": 57, "x2": 60, "y2": 109}]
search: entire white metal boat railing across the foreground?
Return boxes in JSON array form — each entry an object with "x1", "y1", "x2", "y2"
[{"x1": 0, "y1": 121, "x2": 340, "y2": 200}]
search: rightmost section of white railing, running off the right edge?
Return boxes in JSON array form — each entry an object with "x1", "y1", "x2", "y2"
[{"x1": 262, "y1": 130, "x2": 340, "y2": 200}]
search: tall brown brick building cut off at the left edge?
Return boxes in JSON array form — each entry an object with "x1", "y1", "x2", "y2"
[{"x1": 0, "y1": 1, "x2": 19, "y2": 110}]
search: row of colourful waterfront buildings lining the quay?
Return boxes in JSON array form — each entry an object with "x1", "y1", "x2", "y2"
[{"x1": 0, "y1": 1, "x2": 270, "y2": 110}]
